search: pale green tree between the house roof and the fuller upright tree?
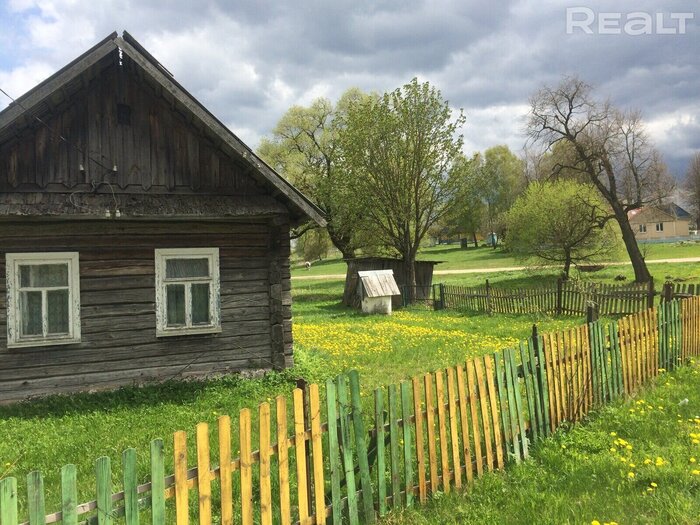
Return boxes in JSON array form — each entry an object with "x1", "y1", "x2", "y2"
[{"x1": 258, "y1": 88, "x2": 367, "y2": 258}]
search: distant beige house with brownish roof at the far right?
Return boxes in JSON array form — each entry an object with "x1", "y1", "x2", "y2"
[{"x1": 628, "y1": 203, "x2": 691, "y2": 241}]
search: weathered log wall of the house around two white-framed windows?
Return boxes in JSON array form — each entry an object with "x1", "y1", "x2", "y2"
[{"x1": 0, "y1": 216, "x2": 292, "y2": 402}]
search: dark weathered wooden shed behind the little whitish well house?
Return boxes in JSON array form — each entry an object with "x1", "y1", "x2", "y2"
[{"x1": 343, "y1": 257, "x2": 439, "y2": 308}]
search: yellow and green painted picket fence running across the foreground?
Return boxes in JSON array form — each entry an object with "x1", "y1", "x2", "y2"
[{"x1": 0, "y1": 297, "x2": 700, "y2": 525}]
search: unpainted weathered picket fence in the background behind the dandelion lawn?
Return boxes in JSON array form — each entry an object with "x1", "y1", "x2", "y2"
[{"x1": 434, "y1": 279, "x2": 655, "y2": 316}]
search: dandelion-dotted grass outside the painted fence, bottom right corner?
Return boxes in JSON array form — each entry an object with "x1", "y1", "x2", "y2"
[{"x1": 384, "y1": 356, "x2": 700, "y2": 525}]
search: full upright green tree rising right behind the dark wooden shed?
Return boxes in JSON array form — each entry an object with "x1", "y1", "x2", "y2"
[{"x1": 342, "y1": 79, "x2": 465, "y2": 296}]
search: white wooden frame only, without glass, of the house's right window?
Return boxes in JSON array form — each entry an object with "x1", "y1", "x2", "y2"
[{"x1": 155, "y1": 248, "x2": 221, "y2": 337}]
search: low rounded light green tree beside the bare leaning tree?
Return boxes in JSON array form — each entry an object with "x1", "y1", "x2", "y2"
[{"x1": 506, "y1": 179, "x2": 617, "y2": 278}]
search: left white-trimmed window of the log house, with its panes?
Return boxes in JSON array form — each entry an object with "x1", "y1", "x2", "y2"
[{"x1": 5, "y1": 252, "x2": 80, "y2": 348}]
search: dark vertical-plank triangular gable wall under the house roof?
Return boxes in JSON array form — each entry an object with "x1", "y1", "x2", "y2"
[{"x1": 0, "y1": 57, "x2": 266, "y2": 196}]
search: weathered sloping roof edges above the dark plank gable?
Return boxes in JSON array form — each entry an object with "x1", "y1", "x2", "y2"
[{"x1": 0, "y1": 31, "x2": 326, "y2": 226}]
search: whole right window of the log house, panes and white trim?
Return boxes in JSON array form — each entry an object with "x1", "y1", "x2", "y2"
[{"x1": 155, "y1": 248, "x2": 221, "y2": 337}]
